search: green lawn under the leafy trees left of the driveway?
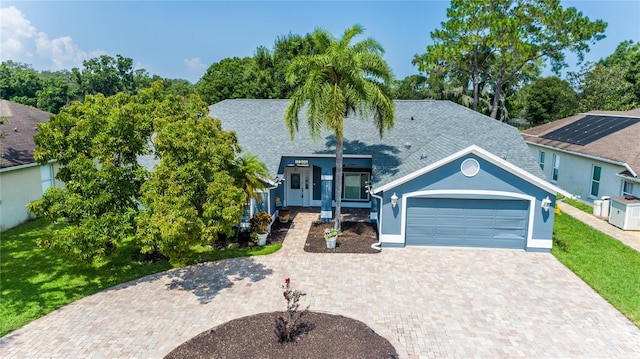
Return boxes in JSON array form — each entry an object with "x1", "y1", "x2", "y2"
[{"x1": 0, "y1": 220, "x2": 282, "y2": 337}]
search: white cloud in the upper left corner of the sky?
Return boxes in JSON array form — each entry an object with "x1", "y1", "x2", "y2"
[{"x1": 0, "y1": 6, "x2": 105, "y2": 70}]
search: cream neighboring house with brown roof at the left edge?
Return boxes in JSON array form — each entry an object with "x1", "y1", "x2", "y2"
[{"x1": 0, "y1": 100, "x2": 62, "y2": 231}]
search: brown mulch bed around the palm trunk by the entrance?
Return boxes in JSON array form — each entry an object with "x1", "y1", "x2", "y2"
[{"x1": 304, "y1": 222, "x2": 379, "y2": 253}]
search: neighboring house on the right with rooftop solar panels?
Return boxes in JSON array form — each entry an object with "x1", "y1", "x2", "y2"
[{"x1": 522, "y1": 109, "x2": 640, "y2": 202}]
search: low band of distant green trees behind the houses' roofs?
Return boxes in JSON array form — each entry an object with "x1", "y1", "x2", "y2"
[{"x1": 0, "y1": 28, "x2": 640, "y2": 125}]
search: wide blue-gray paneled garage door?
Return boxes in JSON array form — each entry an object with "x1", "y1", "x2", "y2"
[{"x1": 406, "y1": 198, "x2": 529, "y2": 249}]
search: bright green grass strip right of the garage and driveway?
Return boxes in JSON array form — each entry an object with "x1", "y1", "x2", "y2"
[{"x1": 551, "y1": 215, "x2": 640, "y2": 328}]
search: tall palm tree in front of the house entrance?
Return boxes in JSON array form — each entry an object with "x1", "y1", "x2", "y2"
[{"x1": 285, "y1": 25, "x2": 394, "y2": 230}]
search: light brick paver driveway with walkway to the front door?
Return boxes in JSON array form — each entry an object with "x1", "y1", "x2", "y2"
[{"x1": 0, "y1": 213, "x2": 640, "y2": 358}]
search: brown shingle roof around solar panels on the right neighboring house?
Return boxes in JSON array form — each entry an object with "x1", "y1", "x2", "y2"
[{"x1": 522, "y1": 108, "x2": 640, "y2": 175}]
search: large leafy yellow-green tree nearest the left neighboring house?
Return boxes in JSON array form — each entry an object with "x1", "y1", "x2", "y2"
[{"x1": 28, "y1": 83, "x2": 161, "y2": 262}]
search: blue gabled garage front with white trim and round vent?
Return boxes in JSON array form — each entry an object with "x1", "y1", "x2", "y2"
[{"x1": 374, "y1": 146, "x2": 571, "y2": 252}]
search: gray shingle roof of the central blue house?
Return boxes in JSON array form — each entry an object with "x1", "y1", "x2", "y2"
[{"x1": 209, "y1": 99, "x2": 545, "y2": 186}]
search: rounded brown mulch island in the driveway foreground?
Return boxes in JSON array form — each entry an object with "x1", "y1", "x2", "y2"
[{"x1": 165, "y1": 312, "x2": 398, "y2": 359}]
